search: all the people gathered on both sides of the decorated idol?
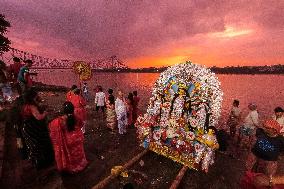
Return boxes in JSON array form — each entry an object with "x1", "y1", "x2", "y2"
[{"x1": 0, "y1": 57, "x2": 284, "y2": 189}]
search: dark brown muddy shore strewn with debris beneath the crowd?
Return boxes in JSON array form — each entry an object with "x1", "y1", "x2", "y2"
[{"x1": 0, "y1": 86, "x2": 284, "y2": 189}]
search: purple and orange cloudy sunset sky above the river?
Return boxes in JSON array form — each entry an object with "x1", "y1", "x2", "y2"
[{"x1": 0, "y1": 0, "x2": 284, "y2": 67}]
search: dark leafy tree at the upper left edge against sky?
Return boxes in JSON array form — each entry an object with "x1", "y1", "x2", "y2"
[{"x1": 0, "y1": 14, "x2": 11, "y2": 55}]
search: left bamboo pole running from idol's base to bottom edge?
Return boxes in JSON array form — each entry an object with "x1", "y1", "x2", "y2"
[{"x1": 92, "y1": 149, "x2": 149, "y2": 189}]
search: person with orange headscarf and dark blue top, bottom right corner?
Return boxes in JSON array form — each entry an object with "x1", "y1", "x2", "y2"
[{"x1": 241, "y1": 120, "x2": 284, "y2": 189}]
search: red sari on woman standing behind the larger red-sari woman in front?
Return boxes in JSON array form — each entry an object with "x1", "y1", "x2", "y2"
[{"x1": 70, "y1": 94, "x2": 87, "y2": 122}]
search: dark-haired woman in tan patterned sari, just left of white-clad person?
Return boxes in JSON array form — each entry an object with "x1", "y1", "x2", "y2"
[{"x1": 106, "y1": 94, "x2": 116, "y2": 133}]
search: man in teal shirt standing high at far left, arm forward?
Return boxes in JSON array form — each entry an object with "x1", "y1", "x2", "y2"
[{"x1": 18, "y1": 60, "x2": 36, "y2": 93}]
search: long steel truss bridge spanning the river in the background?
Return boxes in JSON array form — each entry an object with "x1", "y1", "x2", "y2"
[{"x1": 0, "y1": 48, "x2": 127, "y2": 70}]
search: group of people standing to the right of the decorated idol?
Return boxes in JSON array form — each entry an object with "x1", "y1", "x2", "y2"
[{"x1": 227, "y1": 100, "x2": 284, "y2": 189}]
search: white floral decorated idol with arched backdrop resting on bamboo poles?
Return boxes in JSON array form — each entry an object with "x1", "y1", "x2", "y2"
[{"x1": 136, "y1": 62, "x2": 223, "y2": 172}]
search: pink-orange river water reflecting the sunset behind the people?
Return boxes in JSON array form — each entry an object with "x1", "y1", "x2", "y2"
[{"x1": 35, "y1": 70, "x2": 284, "y2": 127}]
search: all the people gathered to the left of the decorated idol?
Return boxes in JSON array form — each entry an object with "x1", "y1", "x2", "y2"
[{"x1": 0, "y1": 57, "x2": 140, "y2": 176}]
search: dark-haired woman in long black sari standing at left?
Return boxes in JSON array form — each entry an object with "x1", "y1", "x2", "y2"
[{"x1": 22, "y1": 89, "x2": 53, "y2": 169}]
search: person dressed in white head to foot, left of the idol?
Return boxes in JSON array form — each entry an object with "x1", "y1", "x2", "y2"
[{"x1": 115, "y1": 90, "x2": 127, "y2": 134}]
